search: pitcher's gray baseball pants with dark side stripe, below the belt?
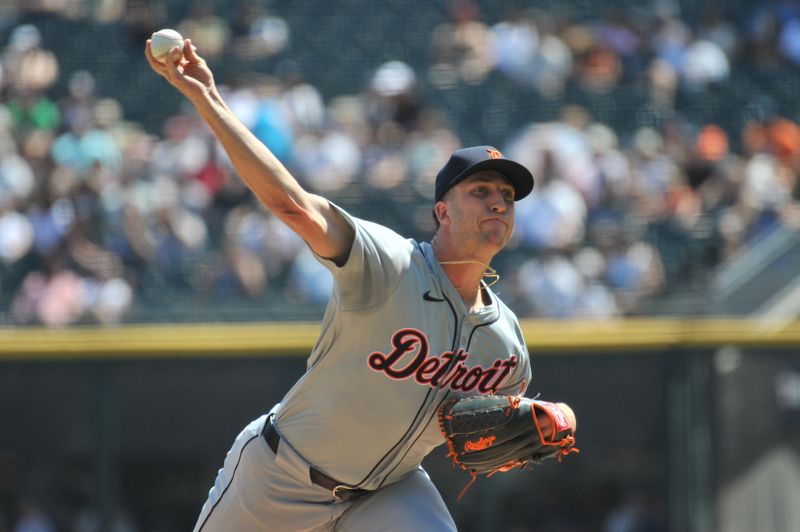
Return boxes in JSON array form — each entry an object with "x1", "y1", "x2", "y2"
[{"x1": 194, "y1": 415, "x2": 456, "y2": 532}]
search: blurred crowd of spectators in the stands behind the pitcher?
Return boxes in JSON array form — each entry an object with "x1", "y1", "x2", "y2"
[{"x1": 0, "y1": 0, "x2": 800, "y2": 326}]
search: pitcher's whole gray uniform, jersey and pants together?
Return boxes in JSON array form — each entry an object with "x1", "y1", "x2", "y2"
[{"x1": 194, "y1": 205, "x2": 531, "y2": 532}]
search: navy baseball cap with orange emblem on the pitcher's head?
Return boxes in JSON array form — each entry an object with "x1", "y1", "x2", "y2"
[{"x1": 435, "y1": 146, "x2": 533, "y2": 201}]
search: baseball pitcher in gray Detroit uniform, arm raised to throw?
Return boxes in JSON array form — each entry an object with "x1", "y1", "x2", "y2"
[{"x1": 145, "y1": 39, "x2": 576, "y2": 532}]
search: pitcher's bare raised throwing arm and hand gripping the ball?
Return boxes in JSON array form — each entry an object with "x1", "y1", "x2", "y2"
[{"x1": 145, "y1": 39, "x2": 354, "y2": 264}]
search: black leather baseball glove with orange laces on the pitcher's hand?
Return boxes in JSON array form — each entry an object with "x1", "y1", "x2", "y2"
[{"x1": 439, "y1": 395, "x2": 578, "y2": 498}]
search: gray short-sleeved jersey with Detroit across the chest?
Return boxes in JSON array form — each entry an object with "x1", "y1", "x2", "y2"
[{"x1": 276, "y1": 204, "x2": 531, "y2": 489}]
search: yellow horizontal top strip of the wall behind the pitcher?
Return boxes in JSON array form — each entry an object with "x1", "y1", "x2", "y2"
[{"x1": 0, "y1": 319, "x2": 800, "y2": 360}]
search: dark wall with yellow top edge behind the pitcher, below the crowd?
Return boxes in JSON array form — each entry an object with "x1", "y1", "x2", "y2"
[{"x1": 0, "y1": 320, "x2": 800, "y2": 532}]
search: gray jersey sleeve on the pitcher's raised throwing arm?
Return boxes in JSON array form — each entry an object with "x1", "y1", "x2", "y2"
[{"x1": 315, "y1": 203, "x2": 413, "y2": 310}]
